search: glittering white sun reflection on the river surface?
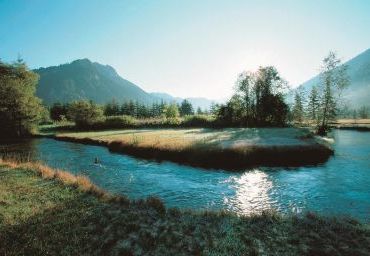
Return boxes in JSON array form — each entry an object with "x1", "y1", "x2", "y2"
[{"x1": 224, "y1": 170, "x2": 273, "y2": 214}]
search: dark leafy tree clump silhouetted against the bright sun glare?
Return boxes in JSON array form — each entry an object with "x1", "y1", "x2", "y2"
[{"x1": 215, "y1": 66, "x2": 289, "y2": 126}]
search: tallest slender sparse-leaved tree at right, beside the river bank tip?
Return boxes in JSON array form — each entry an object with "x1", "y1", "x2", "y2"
[{"x1": 318, "y1": 52, "x2": 349, "y2": 135}]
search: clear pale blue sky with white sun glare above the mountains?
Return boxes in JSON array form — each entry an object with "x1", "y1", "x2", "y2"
[{"x1": 0, "y1": 0, "x2": 370, "y2": 99}]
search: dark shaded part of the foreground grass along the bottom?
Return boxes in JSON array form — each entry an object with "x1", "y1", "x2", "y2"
[{"x1": 0, "y1": 195, "x2": 370, "y2": 256}]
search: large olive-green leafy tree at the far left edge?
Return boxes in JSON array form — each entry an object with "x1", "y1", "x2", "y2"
[{"x1": 0, "y1": 60, "x2": 43, "y2": 138}]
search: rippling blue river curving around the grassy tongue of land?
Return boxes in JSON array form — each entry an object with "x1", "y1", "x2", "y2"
[{"x1": 2, "y1": 130, "x2": 370, "y2": 222}]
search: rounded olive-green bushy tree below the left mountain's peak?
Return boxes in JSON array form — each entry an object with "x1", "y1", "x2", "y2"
[{"x1": 68, "y1": 101, "x2": 104, "y2": 127}]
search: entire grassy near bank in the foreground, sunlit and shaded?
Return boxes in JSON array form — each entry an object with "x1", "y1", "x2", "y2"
[{"x1": 0, "y1": 159, "x2": 370, "y2": 255}]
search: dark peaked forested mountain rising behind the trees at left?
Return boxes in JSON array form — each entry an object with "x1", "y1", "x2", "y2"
[{"x1": 34, "y1": 59, "x2": 155, "y2": 105}]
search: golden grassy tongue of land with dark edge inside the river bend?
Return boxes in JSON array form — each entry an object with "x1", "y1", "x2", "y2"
[{"x1": 56, "y1": 128, "x2": 333, "y2": 170}]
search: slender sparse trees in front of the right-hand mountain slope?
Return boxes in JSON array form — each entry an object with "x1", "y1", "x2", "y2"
[{"x1": 291, "y1": 52, "x2": 349, "y2": 134}]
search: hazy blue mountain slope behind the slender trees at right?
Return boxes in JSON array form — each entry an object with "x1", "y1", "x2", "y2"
[{"x1": 298, "y1": 49, "x2": 370, "y2": 108}]
